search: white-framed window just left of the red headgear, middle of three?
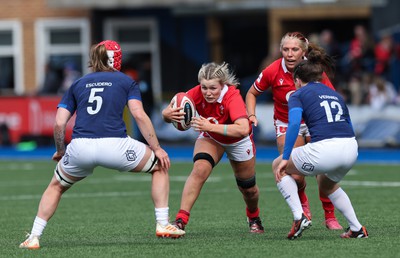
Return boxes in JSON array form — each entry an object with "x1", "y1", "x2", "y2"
[{"x1": 35, "y1": 19, "x2": 90, "y2": 95}]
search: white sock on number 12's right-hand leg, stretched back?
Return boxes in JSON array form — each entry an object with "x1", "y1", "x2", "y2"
[{"x1": 328, "y1": 187, "x2": 362, "y2": 232}]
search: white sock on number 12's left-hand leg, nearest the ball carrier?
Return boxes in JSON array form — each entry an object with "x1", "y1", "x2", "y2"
[{"x1": 276, "y1": 176, "x2": 303, "y2": 220}]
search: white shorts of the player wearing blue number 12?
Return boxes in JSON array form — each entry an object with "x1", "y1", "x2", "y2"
[{"x1": 291, "y1": 137, "x2": 358, "y2": 182}]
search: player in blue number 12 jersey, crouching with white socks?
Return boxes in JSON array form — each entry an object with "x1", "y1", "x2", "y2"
[{"x1": 272, "y1": 46, "x2": 368, "y2": 239}]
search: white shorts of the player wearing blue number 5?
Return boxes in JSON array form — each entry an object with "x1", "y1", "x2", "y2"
[{"x1": 59, "y1": 136, "x2": 146, "y2": 177}]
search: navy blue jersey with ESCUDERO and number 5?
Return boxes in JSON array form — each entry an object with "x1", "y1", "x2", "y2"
[{"x1": 57, "y1": 72, "x2": 141, "y2": 138}]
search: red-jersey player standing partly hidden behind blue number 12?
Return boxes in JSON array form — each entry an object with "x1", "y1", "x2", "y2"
[{"x1": 246, "y1": 32, "x2": 342, "y2": 230}]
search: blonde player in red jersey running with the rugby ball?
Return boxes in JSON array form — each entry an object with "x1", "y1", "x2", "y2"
[{"x1": 162, "y1": 63, "x2": 264, "y2": 233}]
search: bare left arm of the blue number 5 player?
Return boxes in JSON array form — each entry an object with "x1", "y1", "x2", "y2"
[{"x1": 53, "y1": 107, "x2": 72, "y2": 161}]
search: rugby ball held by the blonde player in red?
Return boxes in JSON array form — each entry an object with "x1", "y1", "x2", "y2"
[{"x1": 172, "y1": 92, "x2": 196, "y2": 131}]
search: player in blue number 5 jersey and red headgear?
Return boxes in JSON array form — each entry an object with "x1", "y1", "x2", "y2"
[{"x1": 20, "y1": 40, "x2": 185, "y2": 249}]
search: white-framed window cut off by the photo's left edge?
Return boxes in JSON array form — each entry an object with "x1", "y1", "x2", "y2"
[{"x1": 0, "y1": 20, "x2": 24, "y2": 95}]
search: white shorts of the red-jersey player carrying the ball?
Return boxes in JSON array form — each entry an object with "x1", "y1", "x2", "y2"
[{"x1": 198, "y1": 133, "x2": 255, "y2": 161}]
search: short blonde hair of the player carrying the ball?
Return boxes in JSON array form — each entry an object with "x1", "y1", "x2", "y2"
[{"x1": 197, "y1": 62, "x2": 240, "y2": 87}]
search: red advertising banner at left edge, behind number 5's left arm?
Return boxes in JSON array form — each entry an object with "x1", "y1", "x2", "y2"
[{"x1": 0, "y1": 96, "x2": 75, "y2": 144}]
